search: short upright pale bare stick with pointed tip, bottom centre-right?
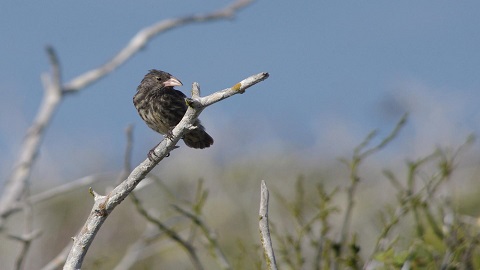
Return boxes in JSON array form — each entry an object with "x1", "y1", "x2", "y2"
[{"x1": 258, "y1": 180, "x2": 277, "y2": 270}]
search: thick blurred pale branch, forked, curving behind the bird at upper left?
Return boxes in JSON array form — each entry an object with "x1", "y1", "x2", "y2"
[{"x1": 0, "y1": 0, "x2": 253, "y2": 230}]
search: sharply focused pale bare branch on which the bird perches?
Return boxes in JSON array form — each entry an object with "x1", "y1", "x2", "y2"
[{"x1": 64, "y1": 72, "x2": 269, "y2": 269}]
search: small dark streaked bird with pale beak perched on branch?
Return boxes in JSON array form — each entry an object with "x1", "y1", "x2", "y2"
[{"x1": 133, "y1": 69, "x2": 213, "y2": 156}]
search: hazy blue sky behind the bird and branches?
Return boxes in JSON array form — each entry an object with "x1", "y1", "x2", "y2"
[{"x1": 0, "y1": 0, "x2": 480, "y2": 181}]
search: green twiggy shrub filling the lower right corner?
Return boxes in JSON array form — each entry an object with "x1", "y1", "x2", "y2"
[{"x1": 266, "y1": 118, "x2": 480, "y2": 269}]
